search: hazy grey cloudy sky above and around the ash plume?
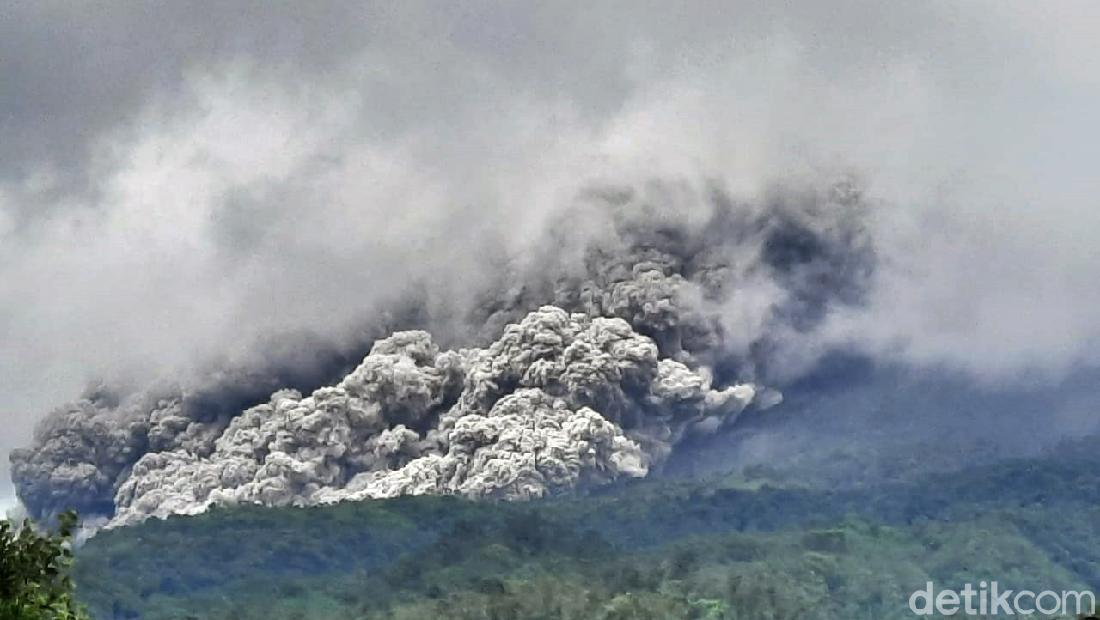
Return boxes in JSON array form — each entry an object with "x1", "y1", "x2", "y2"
[{"x1": 0, "y1": 1, "x2": 1100, "y2": 503}]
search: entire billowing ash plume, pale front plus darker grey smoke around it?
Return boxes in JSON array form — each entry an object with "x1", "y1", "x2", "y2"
[{"x1": 6, "y1": 180, "x2": 875, "y2": 523}]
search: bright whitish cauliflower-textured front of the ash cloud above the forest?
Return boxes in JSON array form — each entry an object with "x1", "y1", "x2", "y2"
[{"x1": 112, "y1": 307, "x2": 756, "y2": 524}]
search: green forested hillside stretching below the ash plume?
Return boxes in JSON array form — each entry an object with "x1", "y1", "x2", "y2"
[{"x1": 75, "y1": 437, "x2": 1100, "y2": 620}]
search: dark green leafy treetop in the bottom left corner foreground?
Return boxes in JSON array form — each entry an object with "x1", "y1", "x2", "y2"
[{"x1": 0, "y1": 512, "x2": 87, "y2": 620}]
